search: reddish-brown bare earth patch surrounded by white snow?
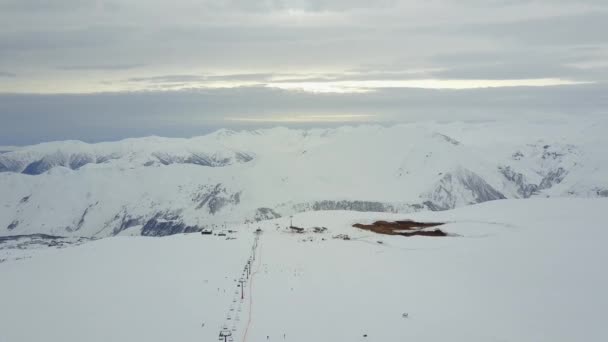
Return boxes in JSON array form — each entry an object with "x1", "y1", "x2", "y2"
[{"x1": 353, "y1": 221, "x2": 448, "y2": 236}]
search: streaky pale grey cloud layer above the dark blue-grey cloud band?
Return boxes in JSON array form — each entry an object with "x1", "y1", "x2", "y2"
[{"x1": 0, "y1": 0, "x2": 608, "y2": 101}]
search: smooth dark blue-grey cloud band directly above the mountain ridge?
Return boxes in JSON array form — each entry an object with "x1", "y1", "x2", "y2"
[{"x1": 0, "y1": 84, "x2": 608, "y2": 144}]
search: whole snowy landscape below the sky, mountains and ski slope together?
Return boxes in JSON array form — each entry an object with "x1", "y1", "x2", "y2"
[{"x1": 0, "y1": 122, "x2": 608, "y2": 342}]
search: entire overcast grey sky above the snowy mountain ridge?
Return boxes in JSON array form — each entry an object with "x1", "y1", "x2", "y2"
[{"x1": 0, "y1": 0, "x2": 608, "y2": 144}]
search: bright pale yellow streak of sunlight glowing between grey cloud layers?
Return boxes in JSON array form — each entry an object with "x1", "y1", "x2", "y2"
[{"x1": 0, "y1": 69, "x2": 593, "y2": 94}]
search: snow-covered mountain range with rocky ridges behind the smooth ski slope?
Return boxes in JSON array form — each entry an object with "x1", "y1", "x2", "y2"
[{"x1": 0, "y1": 122, "x2": 608, "y2": 237}]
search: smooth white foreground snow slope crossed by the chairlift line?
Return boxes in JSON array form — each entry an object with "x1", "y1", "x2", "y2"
[{"x1": 0, "y1": 198, "x2": 608, "y2": 342}]
